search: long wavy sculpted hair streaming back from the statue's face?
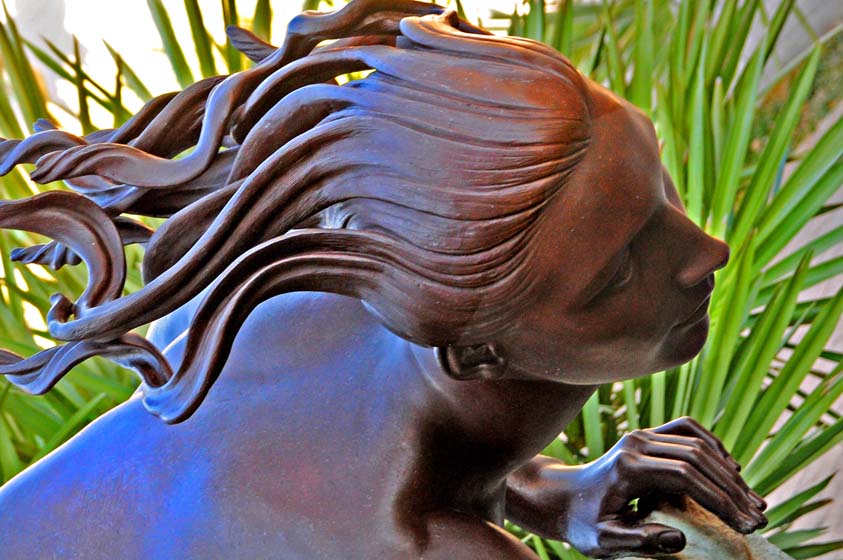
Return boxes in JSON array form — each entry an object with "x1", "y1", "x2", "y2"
[{"x1": 0, "y1": 0, "x2": 591, "y2": 422}]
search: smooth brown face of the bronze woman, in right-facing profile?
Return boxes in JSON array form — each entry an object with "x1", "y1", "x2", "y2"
[{"x1": 499, "y1": 80, "x2": 729, "y2": 383}]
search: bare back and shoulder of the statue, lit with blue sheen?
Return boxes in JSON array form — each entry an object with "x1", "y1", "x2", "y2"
[{"x1": 0, "y1": 293, "x2": 442, "y2": 559}]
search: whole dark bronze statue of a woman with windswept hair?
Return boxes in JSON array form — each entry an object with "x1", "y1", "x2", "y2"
[{"x1": 0, "y1": 0, "x2": 765, "y2": 560}]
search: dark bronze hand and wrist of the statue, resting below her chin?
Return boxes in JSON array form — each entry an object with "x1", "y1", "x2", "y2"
[{"x1": 507, "y1": 418, "x2": 767, "y2": 558}]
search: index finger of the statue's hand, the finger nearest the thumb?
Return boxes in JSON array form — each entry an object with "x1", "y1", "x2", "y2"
[{"x1": 620, "y1": 453, "x2": 766, "y2": 534}]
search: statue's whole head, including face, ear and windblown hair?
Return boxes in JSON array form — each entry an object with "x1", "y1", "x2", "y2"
[{"x1": 0, "y1": 0, "x2": 728, "y2": 421}]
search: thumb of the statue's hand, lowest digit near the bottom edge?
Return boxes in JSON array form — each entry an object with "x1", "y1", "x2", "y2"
[{"x1": 584, "y1": 520, "x2": 685, "y2": 558}]
